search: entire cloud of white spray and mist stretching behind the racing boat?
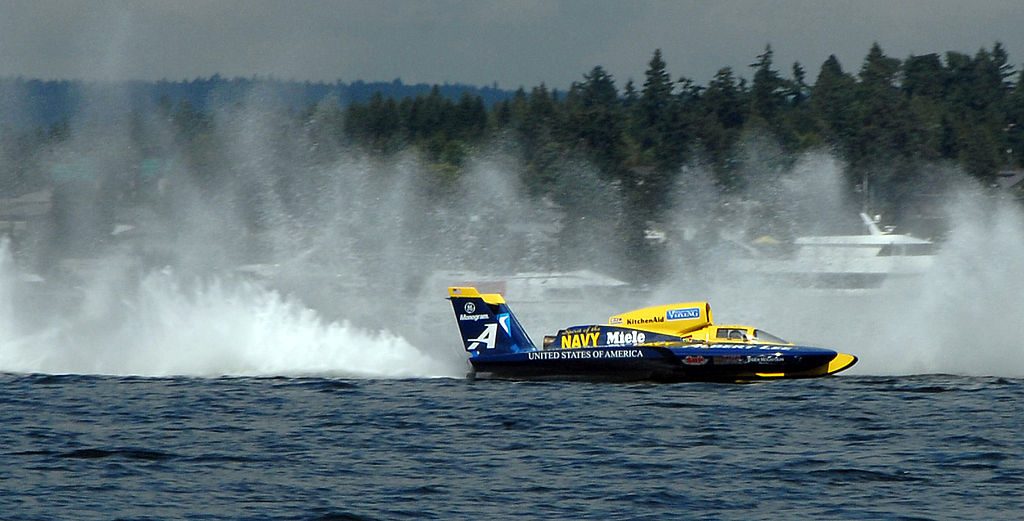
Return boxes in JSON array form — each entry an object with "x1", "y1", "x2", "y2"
[{"x1": 0, "y1": 87, "x2": 1024, "y2": 378}]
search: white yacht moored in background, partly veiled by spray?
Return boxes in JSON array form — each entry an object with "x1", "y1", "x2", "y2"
[{"x1": 729, "y1": 213, "x2": 936, "y2": 290}]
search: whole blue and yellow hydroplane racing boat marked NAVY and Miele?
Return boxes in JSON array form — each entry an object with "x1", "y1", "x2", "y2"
[{"x1": 449, "y1": 288, "x2": 857, "y2": 382}]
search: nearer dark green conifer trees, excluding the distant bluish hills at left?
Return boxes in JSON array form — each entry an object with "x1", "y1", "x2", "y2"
[{"x1": 338, "y1": 43, "x2": 1024, "y2": 222}]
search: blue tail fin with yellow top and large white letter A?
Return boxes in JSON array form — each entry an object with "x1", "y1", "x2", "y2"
[{"x1": 449, "y1": 287, "x2": 537, "y2": 356}]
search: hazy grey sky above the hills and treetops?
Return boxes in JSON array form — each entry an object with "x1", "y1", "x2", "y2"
[{"x1": 0, "y1": 0, "x2": 1024, "y2": 88}]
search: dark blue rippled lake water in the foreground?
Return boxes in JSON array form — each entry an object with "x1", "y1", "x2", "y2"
[{"x1": 0, "y1": 375, "x2": 1024, "y2": 520}]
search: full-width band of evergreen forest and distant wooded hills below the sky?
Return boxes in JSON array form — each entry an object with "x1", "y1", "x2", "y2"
[{"x1": 0, "y1": 42, "x2": 1024, "y2": 280}]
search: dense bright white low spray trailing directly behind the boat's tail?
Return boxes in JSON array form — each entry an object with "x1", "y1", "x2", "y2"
[{"x1": 0, "y1": 241, "x2": 464, "y2": 378}]
